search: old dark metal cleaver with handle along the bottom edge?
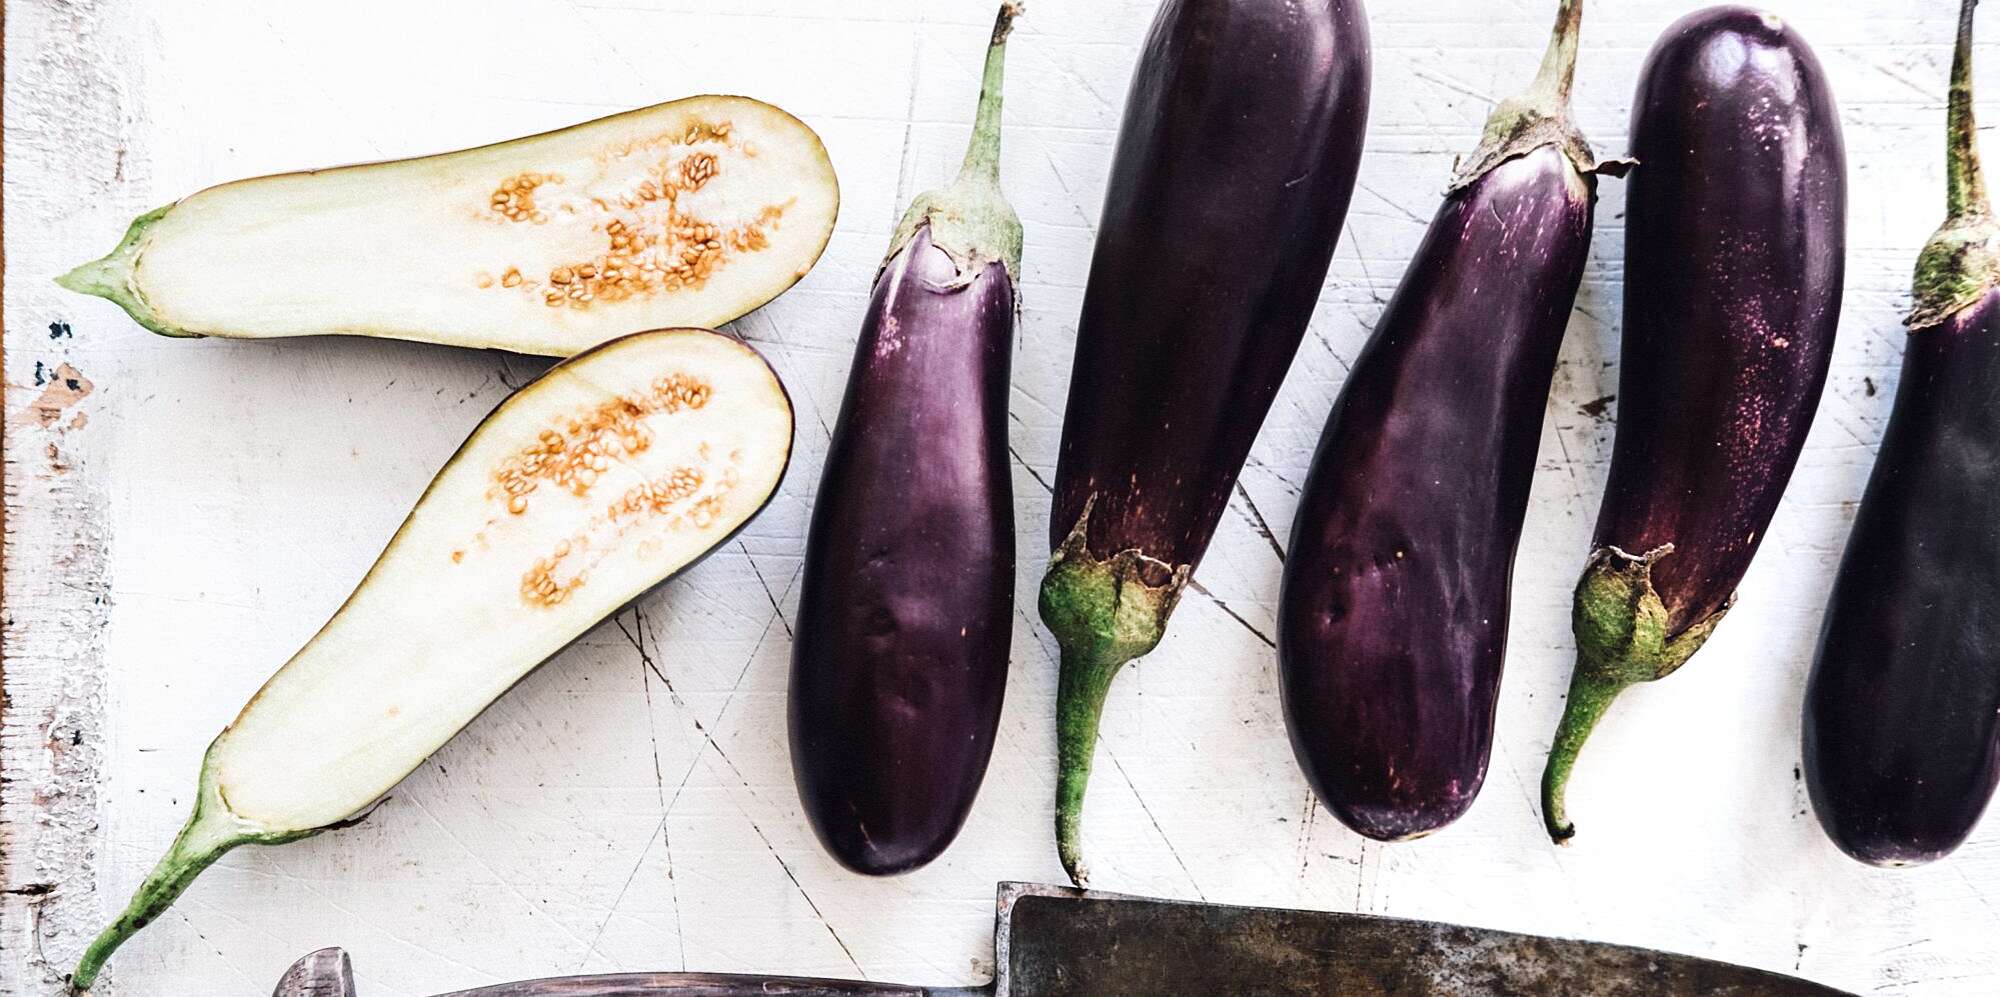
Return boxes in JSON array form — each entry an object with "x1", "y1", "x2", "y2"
[{"x1": 272, "y1": 883, "x2": 1842, "y2": 997}]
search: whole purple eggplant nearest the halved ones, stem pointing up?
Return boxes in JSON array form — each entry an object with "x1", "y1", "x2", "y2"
[{"x1": 790, "y1": 4, "x2": 1020, "y2": 875}]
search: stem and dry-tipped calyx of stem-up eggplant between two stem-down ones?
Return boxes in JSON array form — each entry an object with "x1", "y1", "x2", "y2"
[{"x1": 1450, "y1": 0, "x2": 1632, "y2": 190}]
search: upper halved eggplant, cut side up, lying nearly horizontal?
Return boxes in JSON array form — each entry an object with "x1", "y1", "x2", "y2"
[{"x1": 58, "y1": 96, "x2": 840, "y2": 356}]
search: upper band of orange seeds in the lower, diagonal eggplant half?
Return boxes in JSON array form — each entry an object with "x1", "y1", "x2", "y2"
[{"x1": 494, "y1": 372, "x2": 714, "y2": 517}]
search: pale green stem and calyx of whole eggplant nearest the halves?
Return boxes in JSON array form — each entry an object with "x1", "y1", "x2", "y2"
[{"x1": 882, "y1": 2, "x2": 1024, "y2": 286}]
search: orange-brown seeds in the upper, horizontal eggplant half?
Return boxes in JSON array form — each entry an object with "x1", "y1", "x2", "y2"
[{"x1": 476, "y1": 122, "x2": 786, "y2": 310}]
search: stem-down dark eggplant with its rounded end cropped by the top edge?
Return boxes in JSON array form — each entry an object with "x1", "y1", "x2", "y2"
[{"x1": 1040, "y1": 0, "x2": 1368, "y2": 883}]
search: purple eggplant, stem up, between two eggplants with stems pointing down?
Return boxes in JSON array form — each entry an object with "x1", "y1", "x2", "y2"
[{"x1": 1278, "y1": 0, "x2": 1598, "y2": 841}]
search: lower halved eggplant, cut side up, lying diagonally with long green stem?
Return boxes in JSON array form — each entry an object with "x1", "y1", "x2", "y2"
[{"x1": 72, "y1": 328, "x2": 792, "y2": 989}]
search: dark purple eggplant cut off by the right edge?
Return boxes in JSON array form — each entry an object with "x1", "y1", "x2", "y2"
[{"x1": 1804, "y1": 0, "x2": 2000, "y2": 865}]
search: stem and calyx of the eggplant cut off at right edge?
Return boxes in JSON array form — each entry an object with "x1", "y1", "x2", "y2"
[{"x1": 1904, "y1": 0, "x2": 2000, "y2": 332}]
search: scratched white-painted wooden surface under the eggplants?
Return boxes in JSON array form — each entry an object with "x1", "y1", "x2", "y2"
[{"x1": 0, "y1": 0, "x2": 2000, "y2": 997}]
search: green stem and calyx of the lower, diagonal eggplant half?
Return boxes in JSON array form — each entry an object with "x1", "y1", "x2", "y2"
[{"x1": 70, "y1": 747, "x2": 344, "y2": 993}]
